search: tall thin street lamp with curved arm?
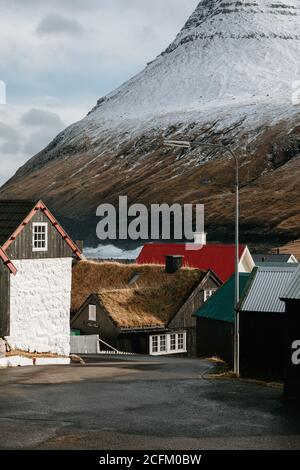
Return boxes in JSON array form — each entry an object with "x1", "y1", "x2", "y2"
[{"x1": 164, "y1": 140, "x2": 240, "y2": 376}]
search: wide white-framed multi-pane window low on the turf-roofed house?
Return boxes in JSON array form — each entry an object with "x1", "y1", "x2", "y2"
[{"x1": 150, "y1": 332, "x2": 186, "y2": 356}]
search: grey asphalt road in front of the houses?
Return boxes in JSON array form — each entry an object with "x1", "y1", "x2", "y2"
[{"x1": 0, "y1": 356, "x2": 300, "y2": 450}]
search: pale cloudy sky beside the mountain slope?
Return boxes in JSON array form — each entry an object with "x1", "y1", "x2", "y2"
[{"x1": 0, "y1": 0, "x2": 198, "y2": 185}]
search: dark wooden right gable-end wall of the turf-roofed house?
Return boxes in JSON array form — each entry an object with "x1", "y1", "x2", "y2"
[{"x1": 168, "y1": 277, "x2": 219, "y2": 357}]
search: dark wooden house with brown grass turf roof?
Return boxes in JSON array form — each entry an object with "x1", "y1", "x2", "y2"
[{"x1": 71, "y1": 260, "x2": 221, "y2": 356}]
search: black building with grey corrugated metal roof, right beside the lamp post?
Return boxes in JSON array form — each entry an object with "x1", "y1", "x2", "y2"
[{"x1": 239, "y1": 263, "x2": 298, "y2": 379}]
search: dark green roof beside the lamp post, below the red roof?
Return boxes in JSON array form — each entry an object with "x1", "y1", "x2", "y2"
[{"x1": 196, "y1": 273, "x2": 251, "y2": 323}]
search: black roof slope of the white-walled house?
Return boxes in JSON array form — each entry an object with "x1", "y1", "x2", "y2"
[{"x1": 0, "y1": 199, "x2": 37, "y2": 246}]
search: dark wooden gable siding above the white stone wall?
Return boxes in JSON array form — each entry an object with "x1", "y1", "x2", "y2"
[{"x1": 6, "y1": 211, "x2": 73, "y2": 260}]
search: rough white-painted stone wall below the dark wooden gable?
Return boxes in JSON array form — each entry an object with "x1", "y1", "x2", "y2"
[{"x1": 7, "y1": 258, "x2": 72, "y2": 356}]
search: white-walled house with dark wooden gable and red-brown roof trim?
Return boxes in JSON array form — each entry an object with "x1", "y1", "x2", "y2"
[{"x1": 0, "y1": 200, "x2": 82, "y2": 356}]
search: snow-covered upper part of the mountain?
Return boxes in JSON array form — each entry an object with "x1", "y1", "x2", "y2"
[{"x1": 87, "y1": 0, "x2": 300, "y2": 125}]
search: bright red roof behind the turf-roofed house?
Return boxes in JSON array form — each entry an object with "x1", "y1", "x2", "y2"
[{"x1": 137, "y1": 243, "x2": 246, "y2": 282}]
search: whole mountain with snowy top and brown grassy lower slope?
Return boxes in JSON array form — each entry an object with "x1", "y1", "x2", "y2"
[{"x1": 0, "y1": 0, "x2": 300, "y2": 246}]
